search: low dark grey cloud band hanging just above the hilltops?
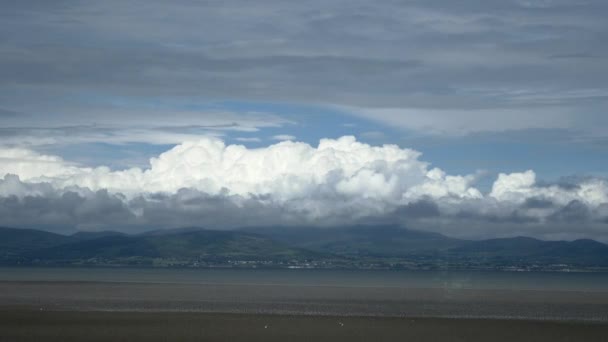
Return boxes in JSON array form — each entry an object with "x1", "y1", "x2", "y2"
[{"x1": 0, "y1": 175, "x2": 608, "y2": 241}]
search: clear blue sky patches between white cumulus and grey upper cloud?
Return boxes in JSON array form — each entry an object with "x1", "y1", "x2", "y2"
[{"x1": 30, "y1": 97, "x2": 608, "y2": 194}]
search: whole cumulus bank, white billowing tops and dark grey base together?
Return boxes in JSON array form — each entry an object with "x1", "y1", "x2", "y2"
[{"x1": 0, "y1": 136, "x2": 608, "y2": 240}]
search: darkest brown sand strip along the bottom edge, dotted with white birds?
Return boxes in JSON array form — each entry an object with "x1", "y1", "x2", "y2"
[{"x1": 0, "y1": 310, "x2": 608, "y2": 342}]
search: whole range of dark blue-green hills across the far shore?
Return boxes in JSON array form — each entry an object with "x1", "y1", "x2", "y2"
[{"x1": 0, "y1": 226, "x2": 608, "y2": 270}]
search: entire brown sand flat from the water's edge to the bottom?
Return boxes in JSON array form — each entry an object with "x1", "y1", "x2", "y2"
[{"x1": 0, "y1": 281, "x2": 608, "y2": 342}]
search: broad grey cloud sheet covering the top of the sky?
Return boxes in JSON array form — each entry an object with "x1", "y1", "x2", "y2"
[{"x1": 0, "y1": 0, "x2": 608, "y2": 138}]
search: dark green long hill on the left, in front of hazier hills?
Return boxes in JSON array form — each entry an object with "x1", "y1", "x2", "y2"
[{"x1": 8, "y1": 229, "x2": 319, "y2": 263}]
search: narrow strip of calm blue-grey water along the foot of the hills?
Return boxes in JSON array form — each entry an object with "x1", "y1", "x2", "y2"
[{"x1": 0, "y1": 267, "x2": 608, "y2": 292}]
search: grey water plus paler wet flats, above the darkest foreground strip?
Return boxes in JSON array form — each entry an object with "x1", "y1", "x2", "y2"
[{"x1": 0, "y1": 267, "x2": 608, "y2": 323}]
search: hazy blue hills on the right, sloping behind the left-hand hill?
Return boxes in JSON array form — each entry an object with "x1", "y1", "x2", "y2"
[{"x1": 242, "y1": 226, "x2": 608, "y2": 268}]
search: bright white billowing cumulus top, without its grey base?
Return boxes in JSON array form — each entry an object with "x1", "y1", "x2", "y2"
[{"x1": 0, "y1": 136, "x2": 481, "y2": 205}]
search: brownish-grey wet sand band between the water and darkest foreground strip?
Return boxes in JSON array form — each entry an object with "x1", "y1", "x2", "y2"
[{"x1": 0, "y1": 281, "x2": 608, "y2": 322}]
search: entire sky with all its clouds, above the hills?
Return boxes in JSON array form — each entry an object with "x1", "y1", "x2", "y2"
[{"x1": 0, "y1": 0, "x2": 608, "y2": 242}]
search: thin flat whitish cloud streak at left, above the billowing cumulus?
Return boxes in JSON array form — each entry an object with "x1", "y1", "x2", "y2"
[{"x1": 0, "y1": 108, "x2": 293, "y2": 146}]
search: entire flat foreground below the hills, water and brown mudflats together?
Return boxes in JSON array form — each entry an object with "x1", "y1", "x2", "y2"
[{"x1": 0, "y1": 269, "x2": 608, "y2": 342}]
